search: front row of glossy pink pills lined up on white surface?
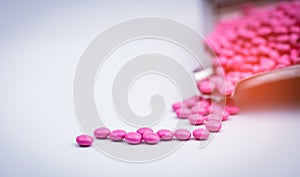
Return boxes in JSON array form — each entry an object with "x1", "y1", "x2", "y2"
[{"x1": 76, "y1": 127, "x2": 210, "y2": 147}]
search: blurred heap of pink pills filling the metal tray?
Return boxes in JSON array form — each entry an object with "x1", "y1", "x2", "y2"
[{"x1": 198, "y1": 1, "x2": 300, "y2": 96}]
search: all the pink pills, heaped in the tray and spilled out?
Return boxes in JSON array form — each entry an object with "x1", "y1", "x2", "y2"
[{"x1": 76, "y1": 1, "x2": 300, "y2": 147}]
